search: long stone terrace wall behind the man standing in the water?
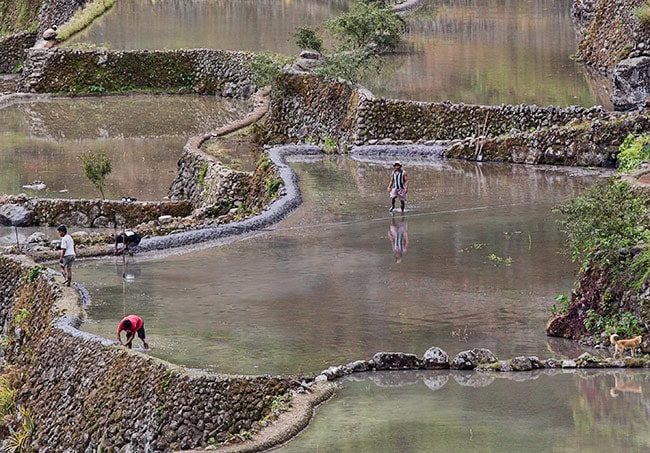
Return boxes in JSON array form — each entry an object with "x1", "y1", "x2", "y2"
[{"x1": 269, "y1": 69, "x2": 650, "y2": 166}]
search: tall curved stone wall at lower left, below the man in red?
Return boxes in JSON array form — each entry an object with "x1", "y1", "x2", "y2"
[{"x1": 0, "y1": 256, "x2": 290, "y2": 451}]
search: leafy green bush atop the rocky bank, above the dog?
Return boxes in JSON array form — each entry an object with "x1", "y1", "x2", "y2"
[{"x1": 554, "y1": 178, "x2": 650, "y2": 268}]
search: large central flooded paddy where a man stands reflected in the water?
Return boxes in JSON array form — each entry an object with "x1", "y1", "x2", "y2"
[{"x1": 75, "y1": 157, "x2": 608, "y2": 373}]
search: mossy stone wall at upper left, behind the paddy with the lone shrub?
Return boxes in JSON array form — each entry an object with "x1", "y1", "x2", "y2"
[{"x1": 19, "y1": 48, "x2": 256, "y2": 99}]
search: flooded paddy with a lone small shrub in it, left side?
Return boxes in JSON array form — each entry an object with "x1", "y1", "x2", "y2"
[{"x1": 0, "y1": 96, "x2": 250, "y2": 200}]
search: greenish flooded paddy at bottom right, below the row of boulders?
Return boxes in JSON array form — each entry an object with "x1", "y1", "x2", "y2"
[{"x1": 278, "y1": 370, "x2": 650, "y2": 453}]
